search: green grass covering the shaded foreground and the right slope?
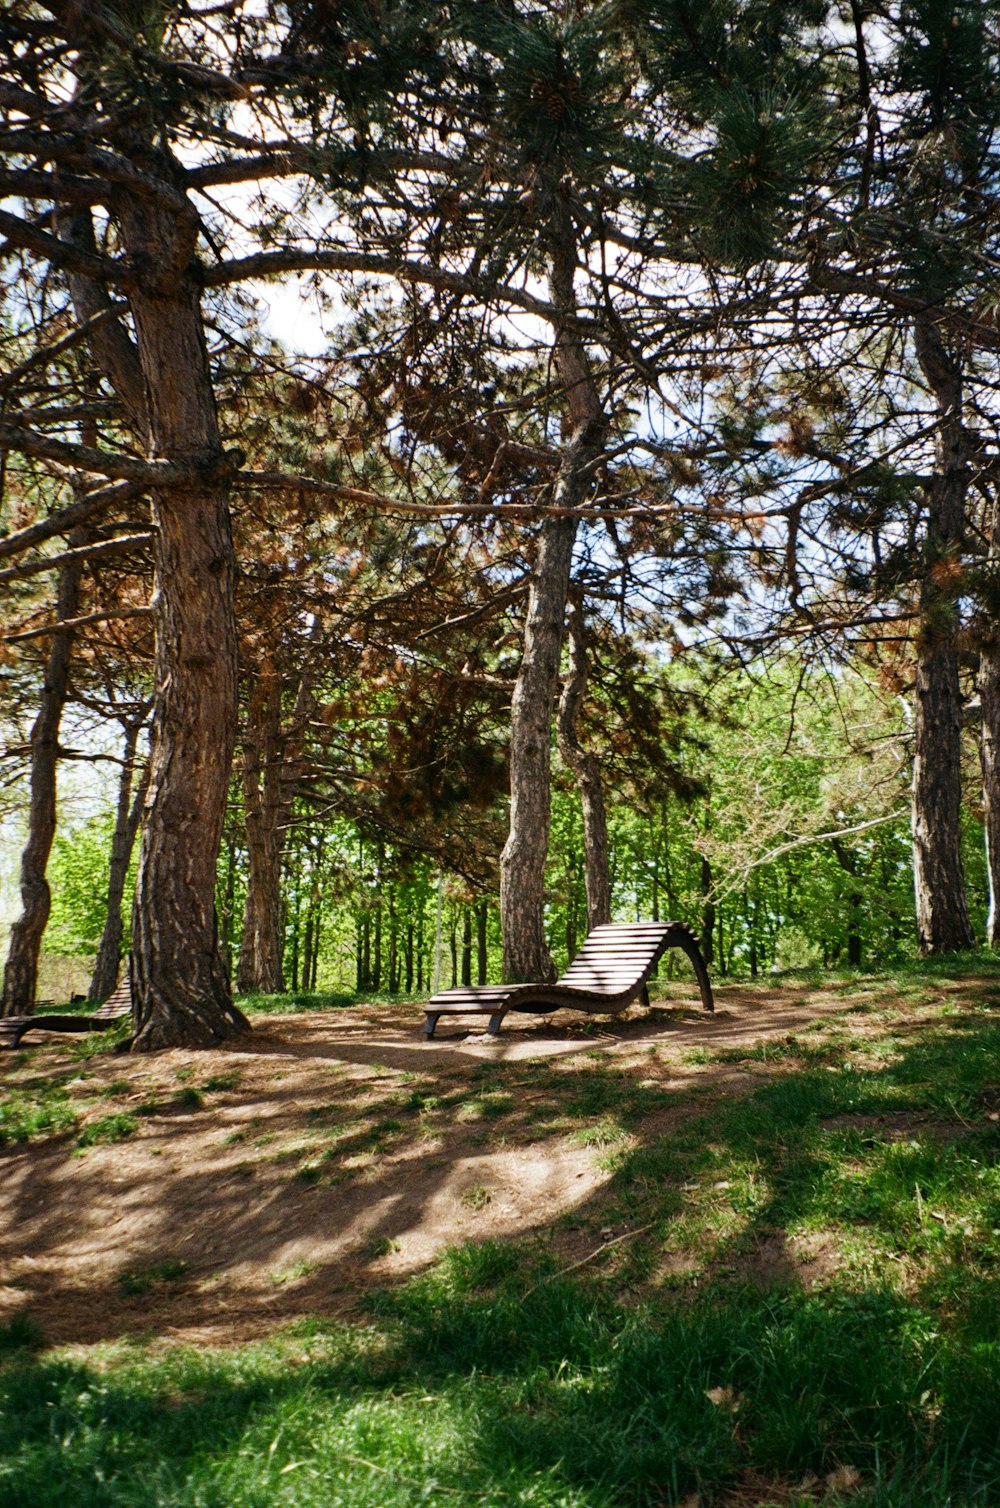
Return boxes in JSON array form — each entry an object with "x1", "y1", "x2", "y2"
[{"x1": 0, "y1": 961, "x2": 1000, "y2": 1508}]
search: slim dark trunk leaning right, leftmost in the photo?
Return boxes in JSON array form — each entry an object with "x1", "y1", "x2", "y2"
[{"x1": 0, "y1": 526, "x2": 86, "y2": 1016}]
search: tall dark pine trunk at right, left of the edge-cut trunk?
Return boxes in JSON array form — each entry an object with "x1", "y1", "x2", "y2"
[{"x1": 913, "y1": 320, "x2": 974, "y2": 953}]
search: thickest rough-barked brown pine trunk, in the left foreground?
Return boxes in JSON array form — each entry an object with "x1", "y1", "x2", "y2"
[{"x1": 119, "y1": 199, "x2": 249, "y2": 1050}]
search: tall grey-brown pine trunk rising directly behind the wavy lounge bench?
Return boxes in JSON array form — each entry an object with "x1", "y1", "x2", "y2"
[{"x1": 501, "y1": 193, "x2": 606, "y2": 983}]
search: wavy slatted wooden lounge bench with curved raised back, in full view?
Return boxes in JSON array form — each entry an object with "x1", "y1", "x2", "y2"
[{"x1": 424, "y1": 921, "x2": 715, "y2": 1039}]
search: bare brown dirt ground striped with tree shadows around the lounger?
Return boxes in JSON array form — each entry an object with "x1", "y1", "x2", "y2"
[{"x1": 0, "y1": 982, "x2": 949, "y2": 1345}]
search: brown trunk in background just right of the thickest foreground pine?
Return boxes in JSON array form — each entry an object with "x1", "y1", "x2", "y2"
[{"x1": 237, "y1": 664, "x2": 285, "y2": 994}]
